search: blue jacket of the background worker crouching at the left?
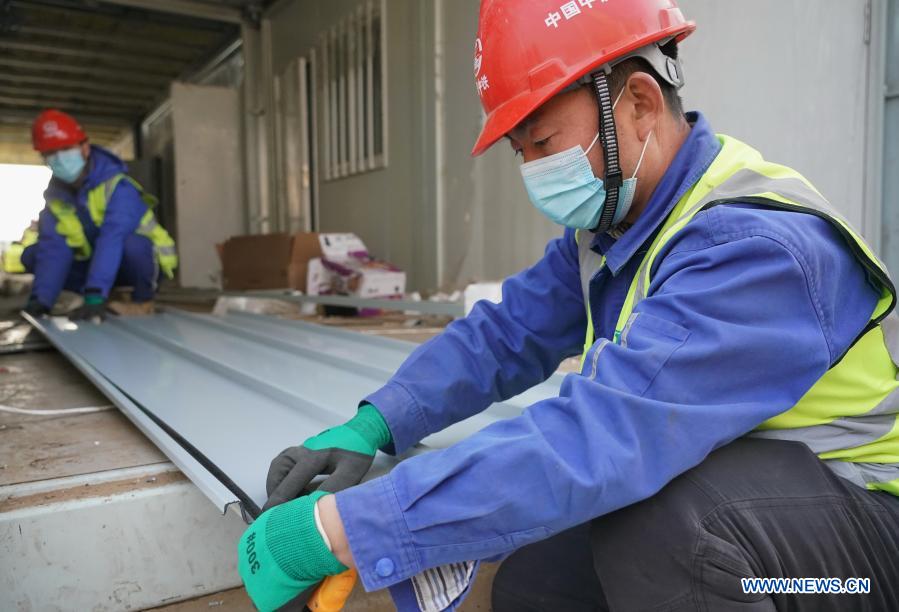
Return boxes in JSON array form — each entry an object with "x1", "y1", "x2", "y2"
[{"x1": 32, "y1": 145, "x2": 147, "y2": 307}]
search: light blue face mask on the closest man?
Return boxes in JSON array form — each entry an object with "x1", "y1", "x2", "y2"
[{"x1": 521, "y1": 90, "x2": 652, "y2": 230}]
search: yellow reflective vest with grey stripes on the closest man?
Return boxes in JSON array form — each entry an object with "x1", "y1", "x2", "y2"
[{"x1": 576, "y1": 136, "x2": 899, "y2": 495}]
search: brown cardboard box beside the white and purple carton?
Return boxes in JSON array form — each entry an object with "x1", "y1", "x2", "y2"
[{"x1": 221, "y1": 233, "x2": 322, "y2": 291}]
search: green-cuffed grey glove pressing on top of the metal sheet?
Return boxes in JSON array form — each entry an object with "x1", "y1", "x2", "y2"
[{"x1": 263, "y1": 404, "x2": 392, "y2": 510}]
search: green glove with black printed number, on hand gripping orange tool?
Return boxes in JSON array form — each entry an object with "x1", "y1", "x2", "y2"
[{"x1": 237, "y1": 491, "x2": 347, "y2": 612}]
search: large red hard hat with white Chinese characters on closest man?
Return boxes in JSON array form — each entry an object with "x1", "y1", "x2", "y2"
[{"x1": 472, "y1": 0, "x2": 696, "y2": 155}]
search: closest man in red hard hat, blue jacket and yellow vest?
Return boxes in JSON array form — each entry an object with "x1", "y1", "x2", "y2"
[{"x1": 239, "y1": 0, "x2": 899, "y2": 612}]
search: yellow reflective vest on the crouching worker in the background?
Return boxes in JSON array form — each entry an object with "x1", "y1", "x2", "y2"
[{"x1": 49, "y1": 174, "x2": 178, "y2": 278}]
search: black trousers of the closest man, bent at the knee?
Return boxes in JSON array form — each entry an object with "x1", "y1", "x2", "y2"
[{"x1": 493, "y1": 438, "x2": 899, "y2": 612}]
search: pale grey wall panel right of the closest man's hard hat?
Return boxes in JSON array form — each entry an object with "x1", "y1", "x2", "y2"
[{"x1": 680, "y1": 0, "x2": 869, "y2": 229}]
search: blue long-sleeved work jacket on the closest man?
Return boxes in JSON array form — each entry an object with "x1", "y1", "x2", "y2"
[{"x1": 337, "y1": 113, "x2": 880, "y2": 609}]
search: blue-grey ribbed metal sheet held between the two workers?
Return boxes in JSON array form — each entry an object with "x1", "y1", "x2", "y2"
[{"x1": 32, "y1": 311, "x2": 562, "y2": 515}]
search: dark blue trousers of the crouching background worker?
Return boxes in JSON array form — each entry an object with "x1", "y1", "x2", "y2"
[{"x1": 22, "y1": 234, "x2": 159, "y2": 302}]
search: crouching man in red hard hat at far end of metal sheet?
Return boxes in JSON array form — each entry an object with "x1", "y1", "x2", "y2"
[{"x1": 21, "y1": 109, "x2": 178, "y2": 320}]
